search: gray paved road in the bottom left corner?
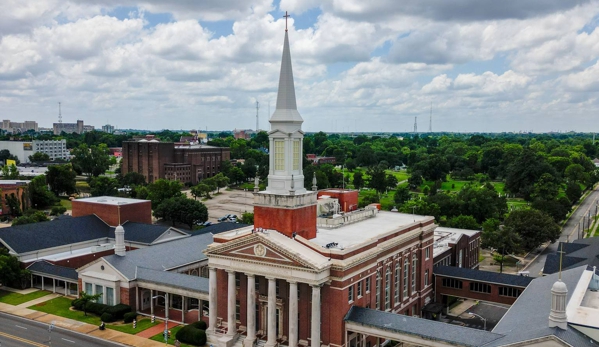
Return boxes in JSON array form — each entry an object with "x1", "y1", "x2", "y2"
[{"x1": 0, "y1": 312, "x2": 123, "y2": 347}]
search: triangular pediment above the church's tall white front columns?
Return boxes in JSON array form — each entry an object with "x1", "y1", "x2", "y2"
[{"x1": 207, "y1": 235, "x2": 315, "y2": 269}]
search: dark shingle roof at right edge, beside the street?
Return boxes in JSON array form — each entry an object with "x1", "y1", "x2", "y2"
[{"x1": 543, "y1": 237, "x2": 599, "y2": 274}]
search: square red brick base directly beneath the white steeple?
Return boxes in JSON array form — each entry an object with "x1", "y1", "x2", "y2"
[{"x1": 254, "y1": 205, "x2": 316, "y2": 240}]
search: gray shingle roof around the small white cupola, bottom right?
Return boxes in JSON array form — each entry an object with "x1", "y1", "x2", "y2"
[{"x1": 488, "y1": 266, "x2": 596, "y2": 347}]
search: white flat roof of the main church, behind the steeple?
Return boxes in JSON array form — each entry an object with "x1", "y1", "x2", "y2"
[{"x1": 310, "y1": 211, "x2": 433, "y2": 248}]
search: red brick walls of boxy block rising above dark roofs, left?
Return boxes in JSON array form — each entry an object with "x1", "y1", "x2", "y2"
[{"x1": 73, "y1": 200, "x2": 152, "y2": 226}]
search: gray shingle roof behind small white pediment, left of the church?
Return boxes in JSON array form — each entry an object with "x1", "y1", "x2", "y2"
[{"x1": 104, "y1": 232, "x2": 213, "y2": 280}]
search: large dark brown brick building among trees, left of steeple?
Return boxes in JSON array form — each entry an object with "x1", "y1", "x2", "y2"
[{"x1": 122, "y1": 136, "x2": 231, "y2": 185}]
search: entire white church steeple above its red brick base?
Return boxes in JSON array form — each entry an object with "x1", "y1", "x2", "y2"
[{"x1": 266, "y1": 23, "x2": 307, "y2": 195}]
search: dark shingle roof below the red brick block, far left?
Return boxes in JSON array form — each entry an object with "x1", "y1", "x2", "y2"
[{"x1": 0, "y1": 215, "x2": 183, "y2": 254}]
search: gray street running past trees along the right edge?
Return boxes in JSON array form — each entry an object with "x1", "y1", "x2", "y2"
[{"x1": 526, "y1": 187, "x2": 599, "y2": 277}]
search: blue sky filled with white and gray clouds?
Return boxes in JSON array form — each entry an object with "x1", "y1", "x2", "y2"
[{"x1": 0, "y1": 0, "x2": 599, "y2": 132}]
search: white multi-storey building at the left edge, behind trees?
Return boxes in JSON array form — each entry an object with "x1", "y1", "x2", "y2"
[{"x1": 0, "y1": 140, "x2": 69, "y2": 163}]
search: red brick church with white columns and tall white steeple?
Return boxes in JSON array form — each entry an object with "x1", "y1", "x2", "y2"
[{"x1": 204, "y1": 25, "x2": 437, "y2": 347}]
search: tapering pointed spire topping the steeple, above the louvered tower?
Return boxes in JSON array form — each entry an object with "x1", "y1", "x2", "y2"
[{"x1": 270, "y1": 32, "x2": 304, "y2": 123}]
